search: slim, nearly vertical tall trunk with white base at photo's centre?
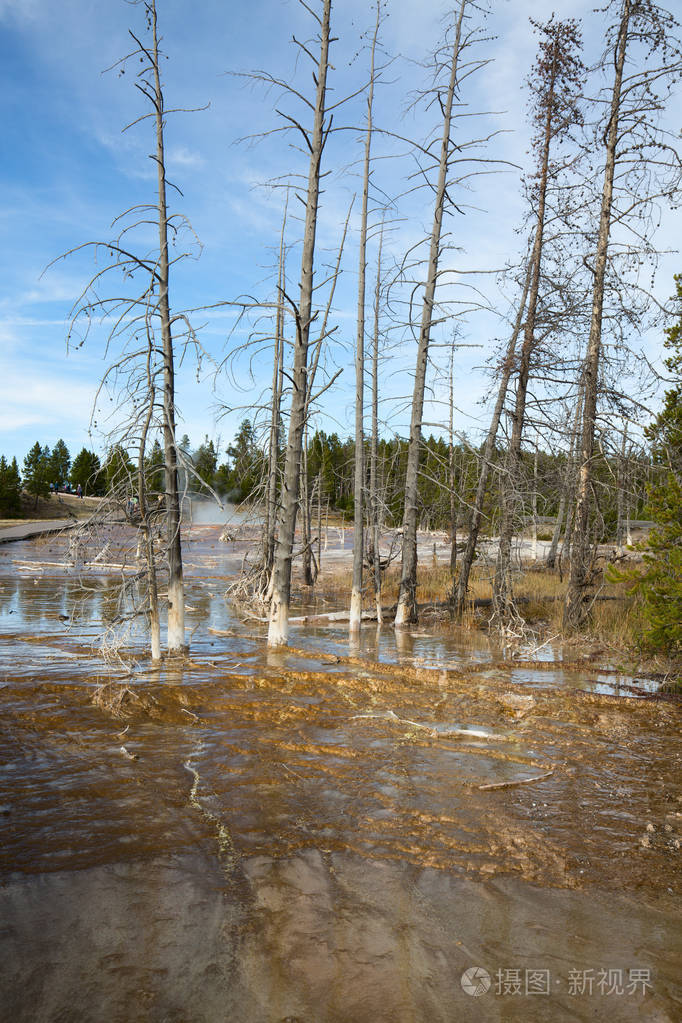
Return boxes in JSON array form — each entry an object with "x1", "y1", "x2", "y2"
[{"x1": 349, "y1": 0, "x2": 380, "y2": 632}]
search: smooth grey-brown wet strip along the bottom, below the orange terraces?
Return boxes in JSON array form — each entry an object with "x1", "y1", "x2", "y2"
[{"x1": 0, "y1": 853, "x2": 682, "y2": 1023}]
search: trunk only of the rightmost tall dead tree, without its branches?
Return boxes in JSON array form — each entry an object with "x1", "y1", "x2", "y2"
[{"x1": 563, "y1": 0, "x2": 633, "y2": 628}]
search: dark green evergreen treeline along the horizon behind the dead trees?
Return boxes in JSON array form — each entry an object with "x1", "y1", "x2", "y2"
[{"x1": 5, "y1": 419, "x2": 652, "y2": 536}]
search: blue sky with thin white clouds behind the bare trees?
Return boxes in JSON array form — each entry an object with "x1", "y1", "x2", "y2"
[{"x1": 0, "y1": 0, "x2": 680, "y2": 468}]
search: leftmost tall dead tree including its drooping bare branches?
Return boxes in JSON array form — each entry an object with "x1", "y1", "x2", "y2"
[{"x1": 53, "y1": 0, "x2": 199, "y2": 657}]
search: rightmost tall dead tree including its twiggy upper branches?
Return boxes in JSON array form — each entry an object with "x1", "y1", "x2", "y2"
[{"x1": 563, "y1": 0, "x2": 682, "y2": 629}]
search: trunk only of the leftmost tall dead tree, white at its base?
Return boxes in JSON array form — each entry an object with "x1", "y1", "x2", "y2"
[{"x1": 147, "y1": 0, "x2": 187, "y2": 654}]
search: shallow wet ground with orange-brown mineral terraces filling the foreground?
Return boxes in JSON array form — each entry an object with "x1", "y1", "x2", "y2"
[{"x1": 0, "y1": 527, "x2": 682, "y2": 1023}]
